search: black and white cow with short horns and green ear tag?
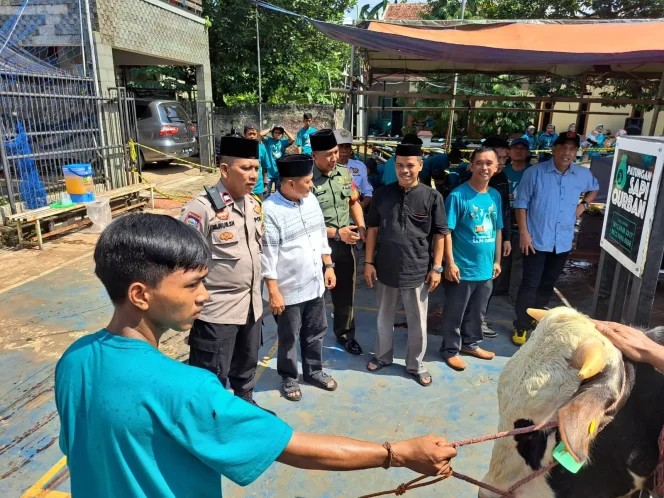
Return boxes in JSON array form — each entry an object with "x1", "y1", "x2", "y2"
[{"x1": 479, "y1": 307, "x2": 664, "y2": 498}]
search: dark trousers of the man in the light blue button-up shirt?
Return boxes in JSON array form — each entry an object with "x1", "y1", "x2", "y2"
[{"x1": 514, "y1": 249, "x2": 569, "y2": 330}]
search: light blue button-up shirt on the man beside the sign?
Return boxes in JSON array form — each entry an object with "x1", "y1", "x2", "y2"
[{"x1": 514, "y1": 159, "x2": 599, "y2": 253}]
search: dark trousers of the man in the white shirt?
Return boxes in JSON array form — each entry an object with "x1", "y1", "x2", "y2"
[{"x1": 274, "y1": 297, "x2": 327, "y2": 381}]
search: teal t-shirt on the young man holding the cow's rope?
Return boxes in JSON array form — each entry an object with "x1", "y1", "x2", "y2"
[{"x1": 55, "y1": 329, "x2": 293, "y2": 498}]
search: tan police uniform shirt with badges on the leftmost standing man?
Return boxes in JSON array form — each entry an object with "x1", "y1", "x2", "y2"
[{"x1": 180, "y1": 181, "x2": 263, "y2": 325}]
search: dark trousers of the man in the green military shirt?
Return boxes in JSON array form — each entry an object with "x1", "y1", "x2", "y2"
[{"x1": 328, "y1": 239, "x2": 356, "y2": 339}]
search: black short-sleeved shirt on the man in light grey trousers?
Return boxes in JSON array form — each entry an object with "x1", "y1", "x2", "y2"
[{"x1": 366, "y1": 183, "x2": 449, "y2": 289}]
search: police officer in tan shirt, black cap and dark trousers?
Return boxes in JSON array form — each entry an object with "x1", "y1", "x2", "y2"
[{"x1": 180, "y1": 136, "x2": 272, "y2": 414}]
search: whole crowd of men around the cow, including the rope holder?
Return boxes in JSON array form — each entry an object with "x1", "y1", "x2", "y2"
[{"x1": 55, "y1": 116, "x2": 640, "y2": 497}]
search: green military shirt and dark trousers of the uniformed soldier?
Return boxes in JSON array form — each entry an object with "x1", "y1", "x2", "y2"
[{"x1": 312, "y1": 165, "x2": 360, "y2": 340}]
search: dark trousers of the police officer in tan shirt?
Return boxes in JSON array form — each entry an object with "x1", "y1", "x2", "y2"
[{"x1": 189, "y1": 311, "x2": 263, "y2": 396}]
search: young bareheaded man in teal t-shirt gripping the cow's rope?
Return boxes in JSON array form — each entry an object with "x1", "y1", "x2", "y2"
[{"x1": 55, "y1": 214, "x2": 456, "y2": 498}]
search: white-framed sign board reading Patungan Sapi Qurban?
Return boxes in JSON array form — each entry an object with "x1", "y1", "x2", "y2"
[{"x1": 600, "y1": 138, "x2": 664, "y2": 278}]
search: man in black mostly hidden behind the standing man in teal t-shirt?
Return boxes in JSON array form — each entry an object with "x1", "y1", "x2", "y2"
[{"x1": 482, "y1": 137, "x2": 512, "y2": 339}]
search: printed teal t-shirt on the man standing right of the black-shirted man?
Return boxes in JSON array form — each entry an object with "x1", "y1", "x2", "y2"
[{"x1": 445, "y1": 183, "x2": 503, "y2": 282}]
